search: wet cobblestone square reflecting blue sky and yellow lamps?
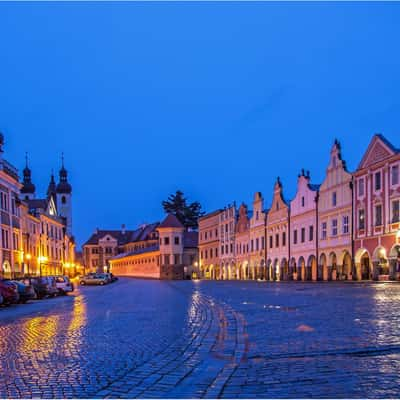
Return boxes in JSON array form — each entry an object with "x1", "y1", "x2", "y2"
[{"x1": 0, "y1": 279, "x2": 400, "y2": 398}]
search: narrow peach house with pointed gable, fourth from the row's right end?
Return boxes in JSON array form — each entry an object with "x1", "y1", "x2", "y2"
[{"x1": 266, "y1": 178, "x2": 293, "y2": 280}]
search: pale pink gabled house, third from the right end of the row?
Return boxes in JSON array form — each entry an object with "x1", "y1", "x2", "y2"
[{"x1": 290, "y1": 170, "x2": 319, "y2": 281}]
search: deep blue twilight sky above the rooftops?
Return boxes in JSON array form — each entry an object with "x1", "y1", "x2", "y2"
[{"x1": 0, "y1": 2, "x2": 400, "y2": 244}]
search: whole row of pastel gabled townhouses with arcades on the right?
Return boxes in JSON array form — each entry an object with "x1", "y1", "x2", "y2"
[{"x1": 194, "y1": 134, "x2": 400, "y2": 281}]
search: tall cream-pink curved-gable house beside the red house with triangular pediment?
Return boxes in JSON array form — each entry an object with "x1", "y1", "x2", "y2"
[{"x1": 317, "y1": 140, "x2": 353, "y2": 280}]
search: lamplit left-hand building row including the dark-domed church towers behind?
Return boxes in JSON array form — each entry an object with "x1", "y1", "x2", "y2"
[{"x1": 0, "y1": 134, "x2": 75, "y2": 278}]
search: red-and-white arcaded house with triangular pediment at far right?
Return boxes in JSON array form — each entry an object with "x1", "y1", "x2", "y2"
[{"x1": 354, "y1": 134, "x2": 400, "y2": 280}]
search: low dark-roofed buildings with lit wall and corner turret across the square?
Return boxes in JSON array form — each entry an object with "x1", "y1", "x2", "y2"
[{"x1": 83, "y1": 214, "x2": 198, "y2": 279}]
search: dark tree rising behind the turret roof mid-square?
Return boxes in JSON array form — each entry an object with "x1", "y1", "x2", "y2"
[{"x1": 162, "y1": 190, "x2": 204, "y2": 228}]
